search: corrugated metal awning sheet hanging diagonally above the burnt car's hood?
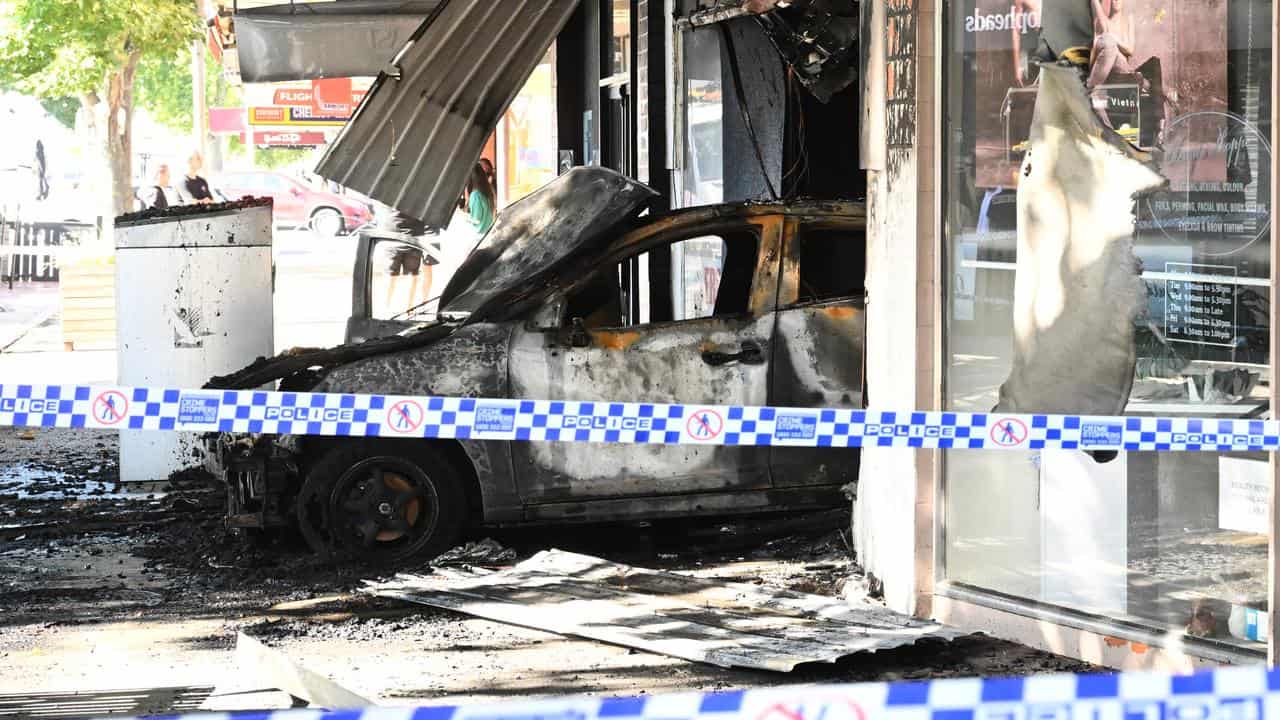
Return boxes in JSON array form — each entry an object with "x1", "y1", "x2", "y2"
[{"x1": 316, "y1": 0, "x2": 577, "y2": 228}]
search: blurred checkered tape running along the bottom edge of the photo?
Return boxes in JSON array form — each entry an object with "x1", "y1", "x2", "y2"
[{"x1": 107, "y1": 666, "x2": 1280, "y2": 720}]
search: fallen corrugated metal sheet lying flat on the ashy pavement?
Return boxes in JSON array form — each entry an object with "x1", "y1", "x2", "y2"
[{"x1": 366, "y1": 550, "x2": 964, "y2": 673}]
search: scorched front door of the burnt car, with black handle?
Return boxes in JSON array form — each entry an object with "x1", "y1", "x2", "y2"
[{"x1": 509, "y1": 217, "x2": 782, "y2": 507}]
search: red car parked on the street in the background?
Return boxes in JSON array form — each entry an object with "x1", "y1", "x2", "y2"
[{"x1": 209, "y1": 172, "x2": 374, "y2": 237}]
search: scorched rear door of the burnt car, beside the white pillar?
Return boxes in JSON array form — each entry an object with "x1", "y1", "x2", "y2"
[{"x1": 771, "y1": 215, "x2": 867, "y2": 488}]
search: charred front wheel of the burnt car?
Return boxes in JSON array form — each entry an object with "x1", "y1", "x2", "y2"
[{"x1": 296, "y1": 441, "x2": 467, "y2": 568}]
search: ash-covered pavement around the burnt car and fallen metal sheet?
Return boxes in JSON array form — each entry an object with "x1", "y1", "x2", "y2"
[{"x1": 0, "y1": 429, "x2": 1093, "y2": 703}]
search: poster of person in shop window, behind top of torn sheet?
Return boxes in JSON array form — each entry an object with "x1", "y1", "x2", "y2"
[{"x1": 963, "y1": 0, "x2": 1229, "y2": 187}]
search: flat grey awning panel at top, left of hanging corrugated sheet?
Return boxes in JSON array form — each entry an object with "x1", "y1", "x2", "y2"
[{"x1": 236, "y1": 0, "x2": 444, "y2": 82}]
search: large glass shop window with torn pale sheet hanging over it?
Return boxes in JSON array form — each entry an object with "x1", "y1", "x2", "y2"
[{"x1": 942, "y1": 0, "x2": 1272, "y2": 653}]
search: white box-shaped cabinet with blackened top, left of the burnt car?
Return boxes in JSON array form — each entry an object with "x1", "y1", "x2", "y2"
[{"x1": 115, "y1": 200, "x2": 273, "y2": 482}]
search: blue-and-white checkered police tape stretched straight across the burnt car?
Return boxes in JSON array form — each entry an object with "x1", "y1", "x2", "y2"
[{"x1": 0, "y1": 384, "x2": 1280, "y2": 452}]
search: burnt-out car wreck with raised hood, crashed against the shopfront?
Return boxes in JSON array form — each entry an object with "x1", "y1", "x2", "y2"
[{"x1": 209, "y1": 168, "x2": 865, "y2": 562}]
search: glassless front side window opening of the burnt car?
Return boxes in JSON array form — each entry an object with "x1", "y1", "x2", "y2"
[{"x1": 566, "y1": 231, "x2": 759, "y2": 328}]
